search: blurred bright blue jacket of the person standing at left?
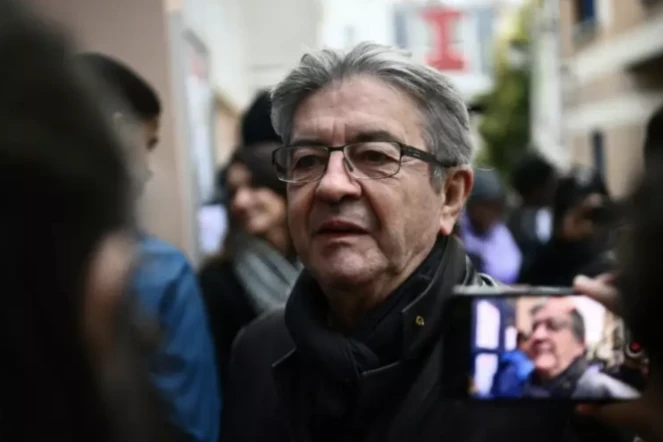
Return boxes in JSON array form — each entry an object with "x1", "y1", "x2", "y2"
[{"x1": 133, "y1": 236, "x2": 221, "y2": 442}]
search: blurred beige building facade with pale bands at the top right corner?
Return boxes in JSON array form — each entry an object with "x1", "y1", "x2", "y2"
[{"x1": 559, "y1": 0, "x2": 663, "y2": 197}]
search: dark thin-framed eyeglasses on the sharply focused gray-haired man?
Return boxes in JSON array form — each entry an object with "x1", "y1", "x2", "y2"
[{"x1": 272, "y1": 141, "x2": 457, "y2": 183}]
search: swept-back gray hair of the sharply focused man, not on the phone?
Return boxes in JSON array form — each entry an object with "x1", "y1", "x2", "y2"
[{"x1": 272, "y1": 42, "x2": 472, "y2": 184}]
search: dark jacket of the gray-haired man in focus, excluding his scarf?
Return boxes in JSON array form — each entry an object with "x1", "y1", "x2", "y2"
[{"x1": 222, "y1": 237, "x2": 626, "y2": 442}]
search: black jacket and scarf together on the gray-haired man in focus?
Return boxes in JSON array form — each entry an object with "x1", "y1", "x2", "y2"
[{"x1": 222, "y1": 238, "x2": 615, "y2": 442}]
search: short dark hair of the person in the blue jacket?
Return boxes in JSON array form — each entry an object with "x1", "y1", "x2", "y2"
[{"x1": 74, "y1": 53, "x2": 161, "y2": 121}]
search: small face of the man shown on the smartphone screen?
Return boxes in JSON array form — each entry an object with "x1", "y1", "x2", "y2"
[{"x1": 530, "y1": 299, "x2": 585, "y2": 379}]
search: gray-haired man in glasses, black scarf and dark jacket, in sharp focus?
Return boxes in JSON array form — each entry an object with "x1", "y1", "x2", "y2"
[{"x1": 222, "y1": 43, "x2": 624, "y2": 442}]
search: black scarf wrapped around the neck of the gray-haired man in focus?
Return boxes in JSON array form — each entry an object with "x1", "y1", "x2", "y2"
[{"x1": 285, "y1": 236, "x2": 474, "y2": 442}]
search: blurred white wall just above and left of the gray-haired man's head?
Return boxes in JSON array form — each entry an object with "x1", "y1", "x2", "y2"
[{"x1": 182, "y1": 0, "x2": 322, "y2": 106}]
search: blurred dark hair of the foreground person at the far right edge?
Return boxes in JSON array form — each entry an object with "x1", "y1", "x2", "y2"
[{"x1": 617, "y1": 152, "x2": 663, "y2": 369}]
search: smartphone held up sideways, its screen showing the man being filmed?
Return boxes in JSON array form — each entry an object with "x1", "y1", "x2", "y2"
[{"x1": 443, "y1": 286, "x2": 641, "y2": 402}]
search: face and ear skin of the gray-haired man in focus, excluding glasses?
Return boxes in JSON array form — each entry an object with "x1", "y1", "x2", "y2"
[{"x1": 288, "y1": 77, "x2": 472, "y2": 297}]
